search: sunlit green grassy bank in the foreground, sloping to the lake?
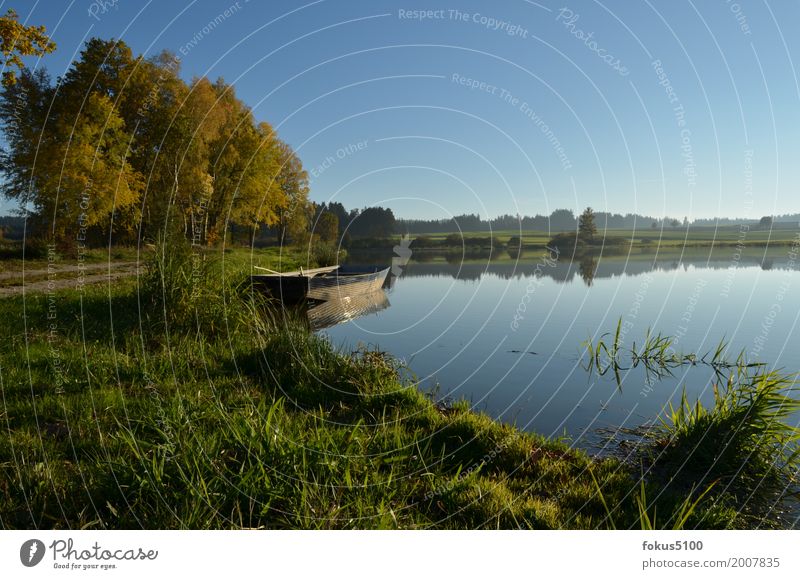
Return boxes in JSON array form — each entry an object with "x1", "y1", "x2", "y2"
[{"x1": 0, "y1": 251, "x2": 792, "y2": 529}]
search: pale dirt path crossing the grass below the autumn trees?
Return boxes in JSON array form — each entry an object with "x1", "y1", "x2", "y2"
[{"x1": 0, "y1": 262, "x2": 137, "y2": 297}]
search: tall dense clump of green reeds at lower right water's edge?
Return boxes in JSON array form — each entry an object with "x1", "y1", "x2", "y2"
[{"x1": 645, "y1": 368, "x2": 800, "y2": 527}]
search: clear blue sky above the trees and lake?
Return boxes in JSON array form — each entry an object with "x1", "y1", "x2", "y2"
[{"x1": 2, "y1": 0, "x2": 800, "y2": 219}]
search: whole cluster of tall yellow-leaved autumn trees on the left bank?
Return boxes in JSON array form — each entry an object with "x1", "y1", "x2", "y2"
[{"x1": 0, "y1": 38, "x2": 313, "y2": 244}]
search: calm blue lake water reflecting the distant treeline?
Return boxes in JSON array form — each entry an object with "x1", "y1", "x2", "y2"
[{"x1": 323, "y1": 247, "x2": 800, "y2": 450}]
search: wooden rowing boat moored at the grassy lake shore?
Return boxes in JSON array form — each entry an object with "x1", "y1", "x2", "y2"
[{"x1": 250, "y1": 265, "x2": 389, "y2": 303}]
